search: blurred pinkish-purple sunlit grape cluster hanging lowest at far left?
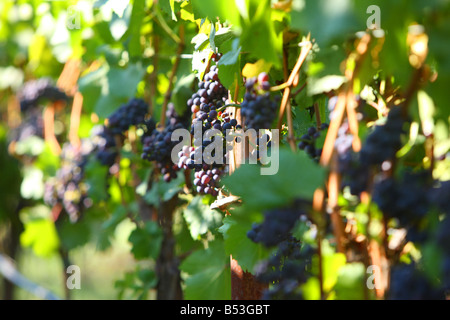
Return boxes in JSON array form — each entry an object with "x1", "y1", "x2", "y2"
[{"x1": 44, "y1": 144, "x2": 92, "y2": 222}]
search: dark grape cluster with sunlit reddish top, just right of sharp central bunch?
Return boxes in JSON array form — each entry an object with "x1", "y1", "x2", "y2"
[{"x1": 241, "y1": 72, "x2": 278, "y2": 131}]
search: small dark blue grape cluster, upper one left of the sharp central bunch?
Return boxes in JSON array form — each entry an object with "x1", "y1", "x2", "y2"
[{"x1": 108, "y1": 98, "x2": 148, "y2": 135}]
